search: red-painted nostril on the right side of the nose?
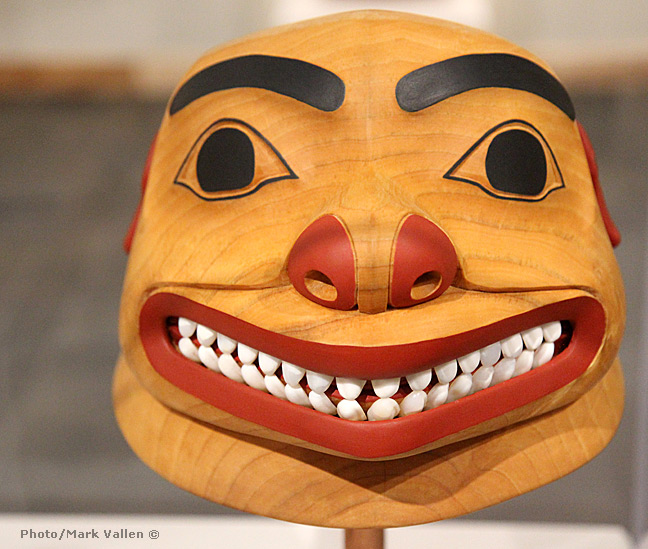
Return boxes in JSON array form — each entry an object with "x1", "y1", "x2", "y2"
[{"x1": 390, "y1": 215, "x2": 457, "y2": 307}]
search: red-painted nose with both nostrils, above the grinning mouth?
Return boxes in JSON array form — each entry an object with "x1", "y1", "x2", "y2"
[{"x1": 287, "y1": 215, "x2": 457, "y2": 312}]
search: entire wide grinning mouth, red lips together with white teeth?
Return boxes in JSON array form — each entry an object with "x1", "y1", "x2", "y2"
[{"x1": 140, "y1": 293, "x2": 605, "y2": 459}]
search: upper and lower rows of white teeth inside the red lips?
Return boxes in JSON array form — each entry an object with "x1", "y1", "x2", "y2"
[{"x1": 173, "y1": 317, "x2": 562, "y2": 420}]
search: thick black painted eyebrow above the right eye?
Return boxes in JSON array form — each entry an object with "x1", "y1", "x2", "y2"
[{"x1": 396, "y1": 53, "x2": 576, "y2": 120}]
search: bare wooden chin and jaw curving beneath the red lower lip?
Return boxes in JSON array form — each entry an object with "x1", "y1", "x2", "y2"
[{"x1": 114, "y1": 354, "x2": 623, "y2": 528}]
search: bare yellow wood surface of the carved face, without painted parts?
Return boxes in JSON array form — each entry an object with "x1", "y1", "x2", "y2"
[{"x1": 115, "y1": 12, "x2": 625, "y2": 528}]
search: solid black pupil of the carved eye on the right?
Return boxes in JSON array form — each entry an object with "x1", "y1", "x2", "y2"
[{"x1": 486, "y1": 130, "x2": 547, "y2": 196}]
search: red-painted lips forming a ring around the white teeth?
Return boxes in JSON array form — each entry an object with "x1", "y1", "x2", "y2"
[{"x1": 140, "y1": 293, "x2": 605, "y2": 458}]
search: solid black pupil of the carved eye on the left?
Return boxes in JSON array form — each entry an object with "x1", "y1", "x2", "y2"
[{"x1": 196, "y1": 128, "x2": 254, "y2": 192}]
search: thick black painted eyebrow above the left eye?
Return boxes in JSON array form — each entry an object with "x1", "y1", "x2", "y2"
[{"x1": 169, "y1": 55, "x2": 345, "y2": 114}]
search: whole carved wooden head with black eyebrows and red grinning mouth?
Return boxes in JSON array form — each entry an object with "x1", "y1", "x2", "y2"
[{"x1": 114, "y1": 12, "x2": 624, "y2": 527}]
